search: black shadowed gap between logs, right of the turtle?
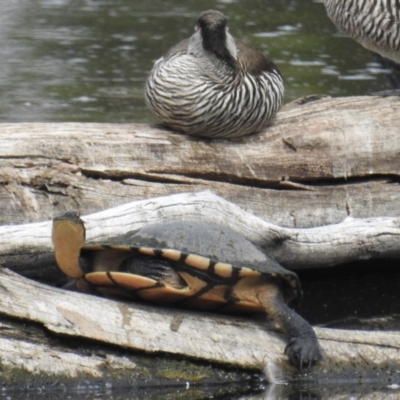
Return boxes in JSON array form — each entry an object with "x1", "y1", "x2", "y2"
[{"x1": 295, "y1": 259, "x2": 400, "y2": 331}]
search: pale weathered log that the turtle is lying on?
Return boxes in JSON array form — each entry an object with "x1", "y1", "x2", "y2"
[{"x1": 0, "y1": 270, "x2": 400, "y2": 381}]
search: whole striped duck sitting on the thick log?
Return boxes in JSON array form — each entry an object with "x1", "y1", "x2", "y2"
[{"x1": 145, "y1": 10, "x2": 284, "y2": 138}]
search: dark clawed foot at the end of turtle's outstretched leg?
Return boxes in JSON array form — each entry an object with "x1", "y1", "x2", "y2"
[{"x1": 285, "y1": 337, "x2": 322, "y2": 370}]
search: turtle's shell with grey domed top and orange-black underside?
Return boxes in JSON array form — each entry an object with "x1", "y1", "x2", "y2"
[{"x1": 53, "y1": 219, "x2": 301, "y2": 311}]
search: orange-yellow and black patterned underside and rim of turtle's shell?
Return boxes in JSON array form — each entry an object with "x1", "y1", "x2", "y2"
[{"x1": 73, "y1": 245, "x2": 299, "y2": 311}]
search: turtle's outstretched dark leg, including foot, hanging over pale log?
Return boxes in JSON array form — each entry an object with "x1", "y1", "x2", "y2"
[{"x1": 257, "y1": 283, "x2": 322, "y2": 369}]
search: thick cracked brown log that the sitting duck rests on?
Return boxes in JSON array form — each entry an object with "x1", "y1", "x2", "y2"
[{"x1": 0, "y1": 97, "x2": 400, "y2": 227}]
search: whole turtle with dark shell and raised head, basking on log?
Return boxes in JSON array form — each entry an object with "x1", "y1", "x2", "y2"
[{"x1": 52, "y1": 211, "x2": 321, "y2": 369}]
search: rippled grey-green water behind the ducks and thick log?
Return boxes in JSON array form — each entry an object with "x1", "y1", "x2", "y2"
[{"x1": 0, "y1": 0, "x2": 396, "y2": 122}]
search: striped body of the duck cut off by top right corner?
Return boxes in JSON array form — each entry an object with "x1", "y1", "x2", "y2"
[{"x1": 324, "y1": 0, "x2": 400, "y2": 63}]
